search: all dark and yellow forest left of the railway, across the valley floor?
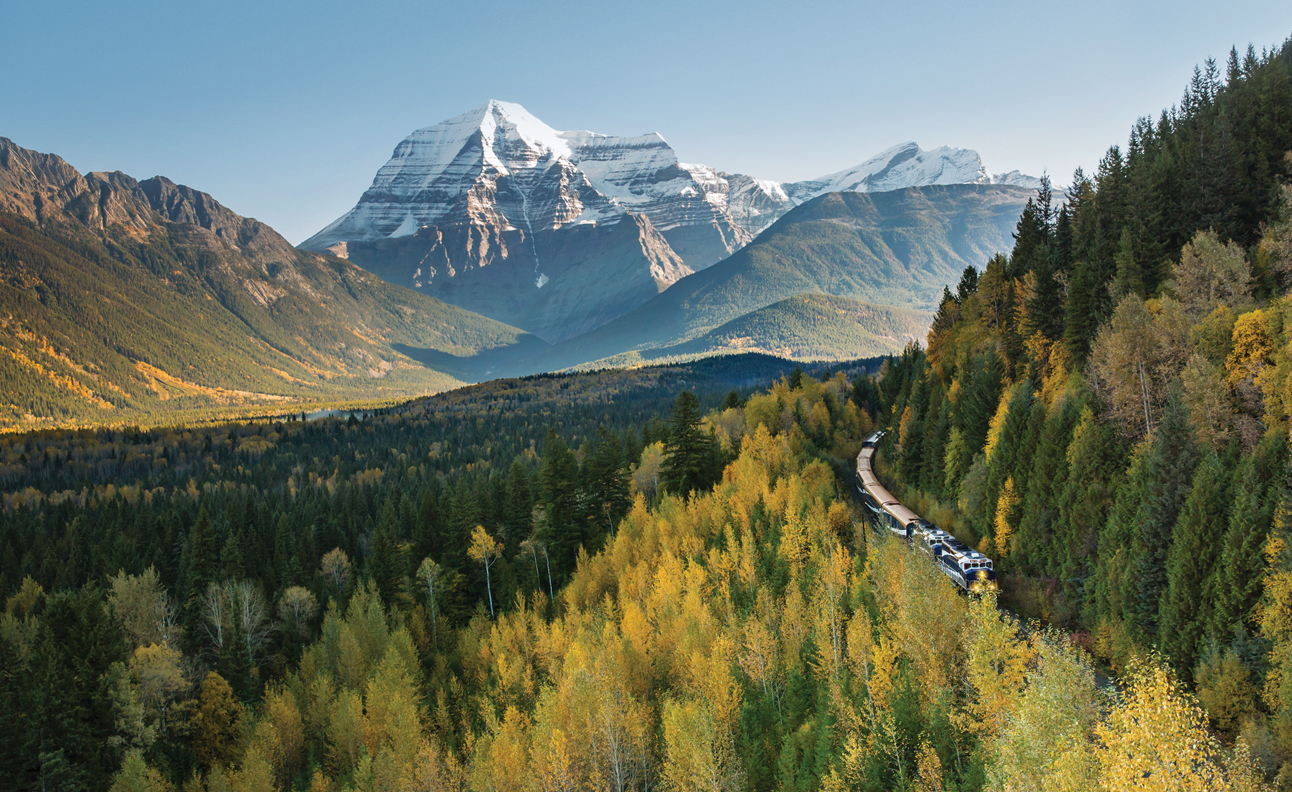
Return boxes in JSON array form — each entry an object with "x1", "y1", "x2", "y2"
[{"x1": 0, "y1": 359, "x2": 1264, "y2": 792}]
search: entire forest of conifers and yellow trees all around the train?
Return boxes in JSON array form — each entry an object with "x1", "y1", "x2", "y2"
[{"x1": 0, "y1": 33, "x2": 1292, "y2": 792}]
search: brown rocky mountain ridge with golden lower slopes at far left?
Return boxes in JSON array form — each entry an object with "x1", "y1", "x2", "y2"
[{"x1": 0, "y1": 138, "x2": 541, "y2": 428}]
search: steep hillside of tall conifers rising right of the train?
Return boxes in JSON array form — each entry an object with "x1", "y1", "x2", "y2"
[{"x1": 871, "y1": 33, "x2": 1292, "y2": 784}]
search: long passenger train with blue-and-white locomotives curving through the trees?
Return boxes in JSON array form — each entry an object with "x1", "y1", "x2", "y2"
[{"x1": 855, "y1": 432, "x2": 996, "y2": 594}]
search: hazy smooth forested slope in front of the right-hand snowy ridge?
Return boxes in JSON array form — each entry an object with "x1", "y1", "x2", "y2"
[{"x1": 550, "y1": 185, "x2": 1032, "y2": 366}]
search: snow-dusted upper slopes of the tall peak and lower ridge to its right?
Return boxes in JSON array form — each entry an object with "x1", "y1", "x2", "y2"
[{"x1": 301, "y1": 99, "x2": 1040, "y2": 254}]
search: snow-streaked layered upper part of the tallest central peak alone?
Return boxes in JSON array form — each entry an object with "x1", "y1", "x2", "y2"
[{"x1": 301, "y1": 102, "x2": 749, "y2": 268}]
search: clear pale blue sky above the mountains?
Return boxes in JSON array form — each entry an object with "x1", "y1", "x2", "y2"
[{"x1": 0, "y1": 0, "x2": 1292, "y2": 243}]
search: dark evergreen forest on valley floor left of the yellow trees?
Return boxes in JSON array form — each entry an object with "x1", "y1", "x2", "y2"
[{"x1": 0, "y1": 357, "x2": 868, "y2": 789}]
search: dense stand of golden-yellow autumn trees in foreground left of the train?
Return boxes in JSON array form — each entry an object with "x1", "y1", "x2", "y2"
[{"x1": 123, "y1": 380, "x2": 1292, "y2": 792}]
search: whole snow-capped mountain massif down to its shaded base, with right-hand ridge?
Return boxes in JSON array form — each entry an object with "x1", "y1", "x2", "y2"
[{"x1": 301, "y1": 101, "x2": 1040, "y2": 342}]
